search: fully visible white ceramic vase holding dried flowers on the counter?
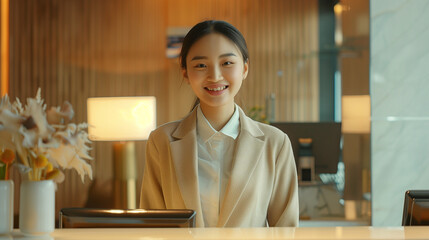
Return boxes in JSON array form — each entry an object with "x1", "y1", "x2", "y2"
[{"x1": 19, "y1": 180, "x2": 55, "y2": 236}]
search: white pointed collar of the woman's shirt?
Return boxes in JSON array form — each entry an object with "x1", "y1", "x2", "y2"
[{"x1": 197, "y1": 105, "x2": 240, "y2": 142}]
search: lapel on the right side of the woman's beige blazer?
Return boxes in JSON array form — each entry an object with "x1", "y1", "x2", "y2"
[{"x1": 218, "y1": 108, "x2": 264, "y2": 227}]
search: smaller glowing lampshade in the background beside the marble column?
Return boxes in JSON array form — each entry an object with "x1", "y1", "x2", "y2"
[{"x1": 342, "y1": 95, "x2": 371, "y2": 133}]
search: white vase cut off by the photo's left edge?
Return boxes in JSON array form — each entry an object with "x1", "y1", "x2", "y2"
[{"x1": 0, "y1": 180, "x2": 13, "y2": 235}]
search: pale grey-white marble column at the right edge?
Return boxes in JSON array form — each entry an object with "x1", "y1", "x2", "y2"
[{"x1": 370, "y1": 0, "x2": 429, "y2": 226}]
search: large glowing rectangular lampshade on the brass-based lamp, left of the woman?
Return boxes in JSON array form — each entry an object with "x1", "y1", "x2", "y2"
[{"x1": 87, "y1": 97, "x2": 156, "y2": 141}]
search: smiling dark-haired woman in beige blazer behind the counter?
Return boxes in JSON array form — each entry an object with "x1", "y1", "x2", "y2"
[{"x1": 140, "y1": 21, "x2": 299, "y2": 227}]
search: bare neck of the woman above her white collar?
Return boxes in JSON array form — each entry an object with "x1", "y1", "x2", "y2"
[{"x1": 200, "y1": 103, "x2": 235, "y2": 131}]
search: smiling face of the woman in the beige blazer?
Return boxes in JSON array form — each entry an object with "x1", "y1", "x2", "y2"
[{"x1": 183, "y1": 33, "x2": 248, "y2": 111}]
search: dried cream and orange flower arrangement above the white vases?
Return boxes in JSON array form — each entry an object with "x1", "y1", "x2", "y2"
[{"x1": 0, "y1": 88, "x2": 92, "y2": 183}]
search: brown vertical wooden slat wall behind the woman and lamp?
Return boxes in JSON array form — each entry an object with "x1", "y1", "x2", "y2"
[{"x1": 6, "y1": 0, "x2": 319, "y2": 215}]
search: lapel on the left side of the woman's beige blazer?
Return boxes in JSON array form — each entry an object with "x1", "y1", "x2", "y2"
[{"x1": 170, "y1": 110, "x2": 204, "y2": 227}]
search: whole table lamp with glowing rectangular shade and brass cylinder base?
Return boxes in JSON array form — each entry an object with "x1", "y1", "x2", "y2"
[{"x1": 87, "y1": 97, "x2": 156, "y2": 209}]
